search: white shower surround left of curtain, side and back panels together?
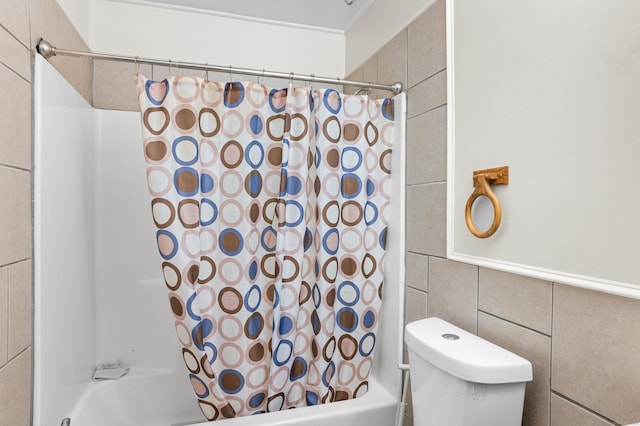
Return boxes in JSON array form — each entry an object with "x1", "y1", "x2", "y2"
[{"x1": 34, "y1": 57, "x2": 188, "y2": 425}]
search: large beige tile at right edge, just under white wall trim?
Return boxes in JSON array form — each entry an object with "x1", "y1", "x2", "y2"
[{"x1": 552, "y1": 284, "x2": 640, "y2": 424}]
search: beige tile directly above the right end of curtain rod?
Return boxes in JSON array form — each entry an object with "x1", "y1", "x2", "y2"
[{"x1": 378, "y1": 30, "x2": 407, "y2": 98}]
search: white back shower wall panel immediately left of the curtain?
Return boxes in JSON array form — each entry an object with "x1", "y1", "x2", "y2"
[{"x1": 95, "y1": 110, "x2": 182, "y2": 368}]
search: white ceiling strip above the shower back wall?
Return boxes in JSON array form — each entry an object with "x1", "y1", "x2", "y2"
[{"x1": 116, "y1": 0, "x2": 375, "y2": 33}]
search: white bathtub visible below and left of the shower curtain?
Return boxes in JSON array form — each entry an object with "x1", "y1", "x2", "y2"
[{"x1": 62, "y1": 369, "x2": 398, "y2": 426}]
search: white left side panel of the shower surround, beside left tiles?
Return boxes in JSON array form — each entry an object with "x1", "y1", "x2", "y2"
[{"x1": 33, "y1": 58, "x2": 96, "y2": 425}]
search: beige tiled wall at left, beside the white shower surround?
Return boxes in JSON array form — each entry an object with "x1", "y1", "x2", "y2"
[{"x1": 0, "y1": 0, "x2": 92, "y2": 426}]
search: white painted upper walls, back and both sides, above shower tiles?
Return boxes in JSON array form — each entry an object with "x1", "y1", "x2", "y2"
[{"x1": 52, "y1": 0, "x2": 435, "y2": 78}]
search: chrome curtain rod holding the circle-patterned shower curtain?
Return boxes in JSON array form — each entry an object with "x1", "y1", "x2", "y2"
[{"x1": 37, "y1": 39, "x2": 402, "y2": 94}]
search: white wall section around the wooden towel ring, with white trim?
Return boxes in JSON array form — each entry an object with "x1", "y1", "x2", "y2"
[{"x1": 447, "y1": 0, "x2": 640, "y2": 298}]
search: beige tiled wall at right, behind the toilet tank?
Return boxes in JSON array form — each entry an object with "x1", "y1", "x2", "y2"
[{"x1": 349, "y1": 0, "x2": 640, "y2": 426}]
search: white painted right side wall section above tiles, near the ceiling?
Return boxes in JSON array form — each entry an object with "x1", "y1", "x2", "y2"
[{"x1": 345, "y1": 0, "x2": 435, "y2": 75}]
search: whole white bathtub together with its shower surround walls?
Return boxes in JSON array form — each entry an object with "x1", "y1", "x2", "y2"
[{"x1": 33, "y1": 56, "x2": 406, "y2": 426}]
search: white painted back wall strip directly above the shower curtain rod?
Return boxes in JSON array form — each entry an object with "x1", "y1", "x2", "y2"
[{"x1": 86, "y1": 0, "x2": 345, "y2": 77}]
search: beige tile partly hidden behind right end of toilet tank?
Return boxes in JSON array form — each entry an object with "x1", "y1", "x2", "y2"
[{"x1": 478, "y1": 312, "x2": 551, "y2": 426}]
